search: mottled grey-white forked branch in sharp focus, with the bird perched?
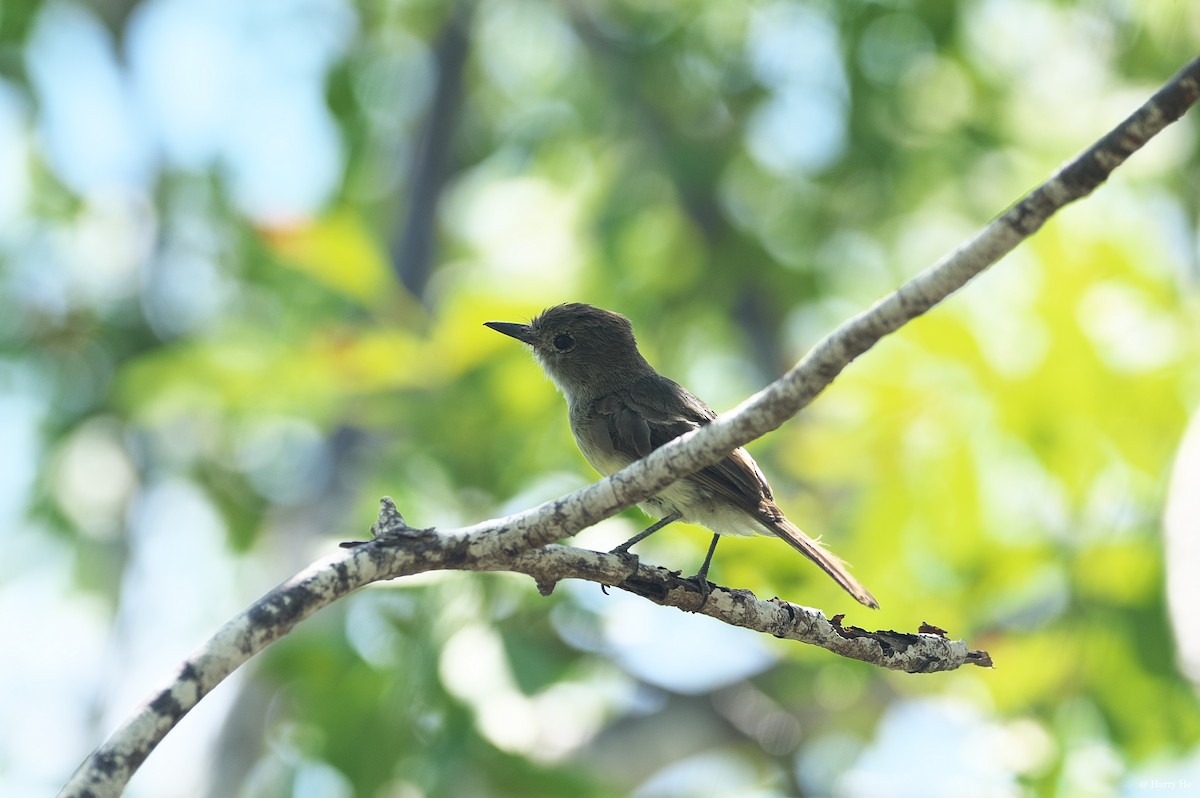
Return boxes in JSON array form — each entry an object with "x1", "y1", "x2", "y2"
[{"x1": 60, "y1": 59, "x2": 1200, "y2": 798}]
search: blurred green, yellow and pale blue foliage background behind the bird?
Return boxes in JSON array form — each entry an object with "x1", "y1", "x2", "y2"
[{"x1": 0, "y1": 0, "x2": 1200, "y2": 798}]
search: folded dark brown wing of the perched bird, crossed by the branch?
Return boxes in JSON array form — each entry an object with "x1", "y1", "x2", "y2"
[{"x1": 593, "y1": 376, "x2": 772, "y2": 515}]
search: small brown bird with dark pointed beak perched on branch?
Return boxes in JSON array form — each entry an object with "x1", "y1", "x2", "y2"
[{"x1": 486, "y1": 304, "x2": 880, "y2": 608}]
